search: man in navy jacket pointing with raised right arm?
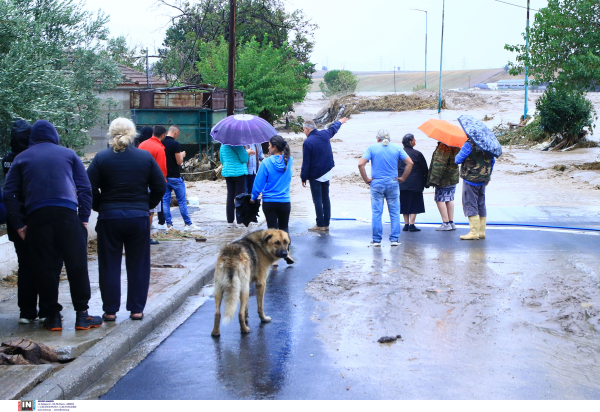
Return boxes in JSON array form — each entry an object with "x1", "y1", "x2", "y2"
[{"x1": 300, "y1": 117, "x2": 348, "y2": 232}]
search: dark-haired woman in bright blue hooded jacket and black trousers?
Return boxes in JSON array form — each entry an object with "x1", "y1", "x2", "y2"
[{"x1": 251, "y1": 136, "x2": 294, "y2": 263}]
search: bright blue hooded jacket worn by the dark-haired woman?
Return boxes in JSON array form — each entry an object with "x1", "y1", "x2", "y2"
[{"x1": 252, "y1": 155, "x2": 294, "y2": 203}]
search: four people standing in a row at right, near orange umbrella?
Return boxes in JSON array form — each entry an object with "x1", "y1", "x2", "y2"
[{"x1": 358, "y1": 130, "x2": 495, "y2": 247}]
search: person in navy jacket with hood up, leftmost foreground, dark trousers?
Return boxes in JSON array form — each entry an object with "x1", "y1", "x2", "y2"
[{"x1": 4, "y1": 120, "x2": 102, "y2": 331}]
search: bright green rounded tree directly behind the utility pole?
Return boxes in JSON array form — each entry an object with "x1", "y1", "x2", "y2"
[{"x1": 196, "y1": 38, "x2": 310, "y2": 124}]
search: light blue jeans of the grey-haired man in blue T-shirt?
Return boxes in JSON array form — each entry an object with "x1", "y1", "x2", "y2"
[{"x1": 371, "y1": 179, "x2": 400, "y2": 242}]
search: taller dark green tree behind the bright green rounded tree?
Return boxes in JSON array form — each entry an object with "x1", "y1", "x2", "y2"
[{"x1": 155, "y1": 0, "x2": 318, "y2": 84}]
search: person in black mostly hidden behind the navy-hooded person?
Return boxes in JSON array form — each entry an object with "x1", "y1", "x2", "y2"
[{"x1": 2, "y1": 120, "x2": 62, "y2": 324}]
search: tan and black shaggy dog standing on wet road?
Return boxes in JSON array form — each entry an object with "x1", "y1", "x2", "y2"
[{"x1": 211, "y1": 229, "x2": 293, "y2": 336}]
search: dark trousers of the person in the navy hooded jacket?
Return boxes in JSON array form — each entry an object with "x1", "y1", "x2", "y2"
[{"x1": 25, "y1": 206, "x2": 91, "y2": 316}]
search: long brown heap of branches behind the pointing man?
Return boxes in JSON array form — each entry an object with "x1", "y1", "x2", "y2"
[{"x1": 314, "y1": 94, "x2": 446, "y2": 126}]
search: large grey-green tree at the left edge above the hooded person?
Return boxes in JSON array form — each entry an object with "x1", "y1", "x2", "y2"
[{"x1": 0, "y1": 0, "x2": 120, "y2": 150}]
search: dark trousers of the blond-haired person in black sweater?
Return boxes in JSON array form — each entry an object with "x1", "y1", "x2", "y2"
[{"x1": 96, "y1": 217, "x2": 150, "y2": 313}]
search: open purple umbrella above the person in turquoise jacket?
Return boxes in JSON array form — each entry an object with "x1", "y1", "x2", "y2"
[{"x1": 210, "y1": 114, "x2": 277, "y2": 146}]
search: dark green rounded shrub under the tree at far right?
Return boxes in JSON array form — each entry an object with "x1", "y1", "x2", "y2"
[{"x1": 536, "y1": 87, "x2": 597, "y2": 150}]
